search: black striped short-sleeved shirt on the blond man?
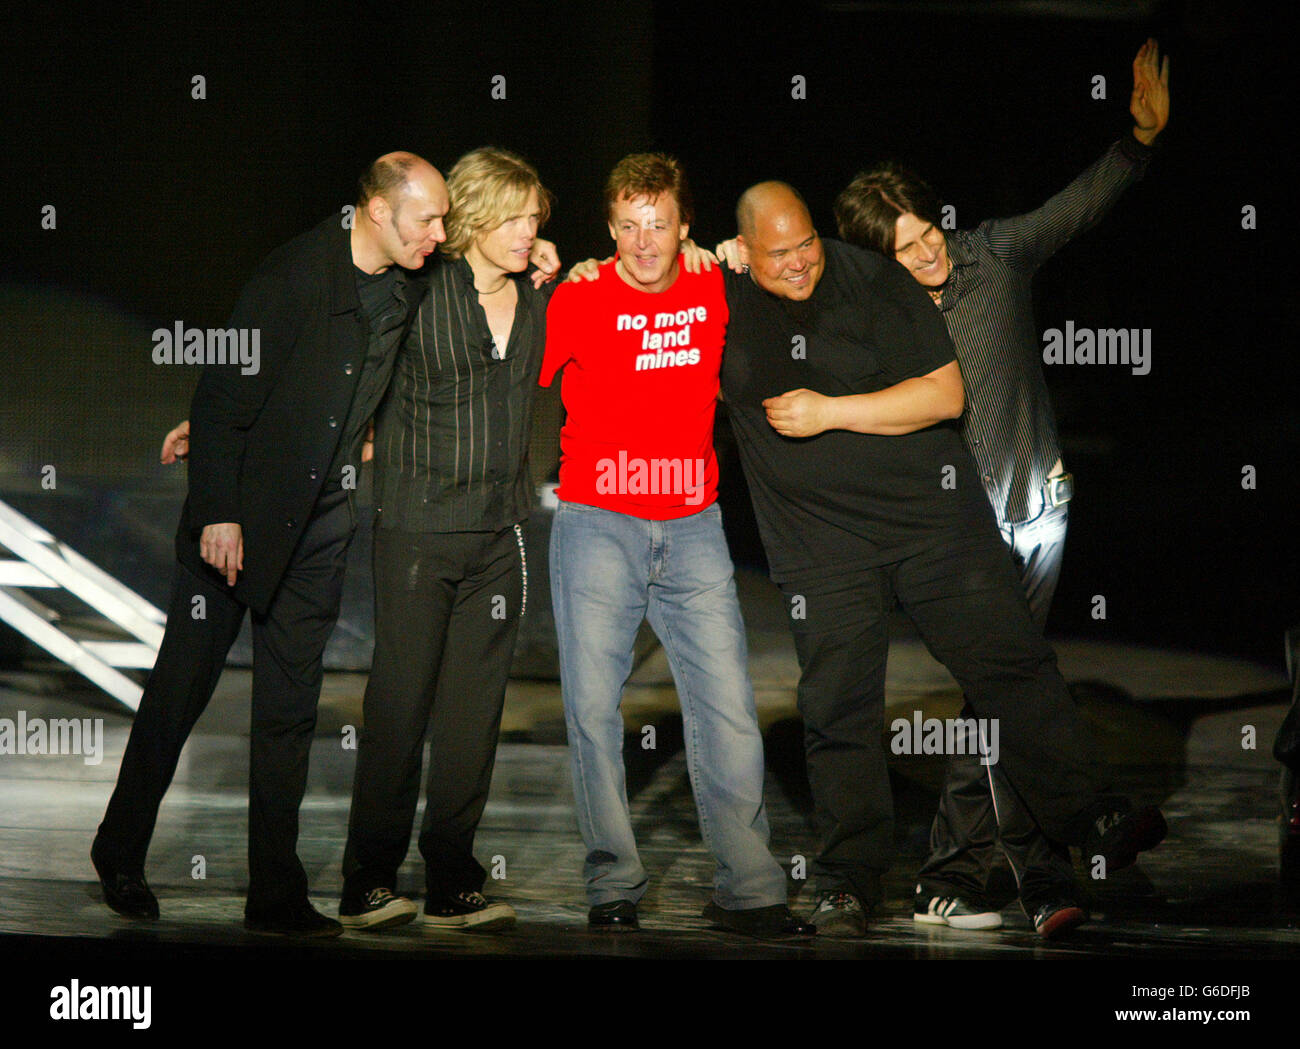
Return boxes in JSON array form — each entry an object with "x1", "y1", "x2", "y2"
[{"x1": 374, "y1": 255, "x2": 554, "y2": 532}]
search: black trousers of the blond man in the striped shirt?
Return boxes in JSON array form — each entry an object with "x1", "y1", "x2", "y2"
[{"x1": 343, "y1": 528, "x2": 523, "y2": 902}]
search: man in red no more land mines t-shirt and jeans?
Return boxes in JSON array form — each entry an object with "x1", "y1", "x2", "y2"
[{"x1": 541, "y1": 153, "x2": 814, "y2": 935}]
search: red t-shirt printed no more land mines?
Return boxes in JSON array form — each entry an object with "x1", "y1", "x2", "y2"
[{"x1": 540, "y1": 259, "x2": 727, "y2": 521}]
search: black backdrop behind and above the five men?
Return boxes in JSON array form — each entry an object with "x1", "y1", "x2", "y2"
[{"x1": 0, "y1": 0, "x2": 1300, "y2": 663}]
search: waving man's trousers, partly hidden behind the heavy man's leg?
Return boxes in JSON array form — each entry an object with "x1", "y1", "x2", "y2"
[{"x1": 918, "y1": 504, "x2": 1080, "y2": 916}]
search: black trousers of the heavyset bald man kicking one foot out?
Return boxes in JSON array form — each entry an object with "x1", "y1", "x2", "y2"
[{"x1": 781, "y1": 525, "x2": 1113, "y2": 902}]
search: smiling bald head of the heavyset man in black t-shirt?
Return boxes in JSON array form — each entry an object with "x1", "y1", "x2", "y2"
[{"x1": 736, "y1": 182, "x2": 826, "y2": 300}]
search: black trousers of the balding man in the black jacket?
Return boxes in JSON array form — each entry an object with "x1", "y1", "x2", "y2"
[{"x1": 99, "y1": 491, "x2": 354, "y2": 911}]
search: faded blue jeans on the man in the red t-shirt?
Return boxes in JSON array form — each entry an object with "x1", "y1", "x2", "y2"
[{"x1": 551, "y1": 502, "x2": 787, "y2": 910}]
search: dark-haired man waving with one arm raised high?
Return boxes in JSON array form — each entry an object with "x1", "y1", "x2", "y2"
[{"x1": 835, "y1": 40, "x2": 1169, "y2": 936}]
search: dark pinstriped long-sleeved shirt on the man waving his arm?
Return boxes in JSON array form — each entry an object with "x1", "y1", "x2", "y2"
[{"x1": 940, "y1": 134, "x2": 1154, "y2": 523}]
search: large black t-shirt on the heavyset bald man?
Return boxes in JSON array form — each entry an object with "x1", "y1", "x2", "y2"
[{"x1": 722, "y1": 240, "x2": 992, "y2": 582}]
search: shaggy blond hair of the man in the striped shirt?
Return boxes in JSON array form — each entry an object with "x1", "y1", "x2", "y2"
[{"x1": 441, "y1": 146, "x2": 551, "y2": 259}]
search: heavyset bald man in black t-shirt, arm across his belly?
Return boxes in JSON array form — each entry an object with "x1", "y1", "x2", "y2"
[{"x1": 722, "y1": 182, "x2": 1165, "y2": 936}]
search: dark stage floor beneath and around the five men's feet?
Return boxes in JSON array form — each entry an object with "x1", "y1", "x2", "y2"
[{"x1": 0, "y1": 576, "x2": 1300, "y2": 1029}]
